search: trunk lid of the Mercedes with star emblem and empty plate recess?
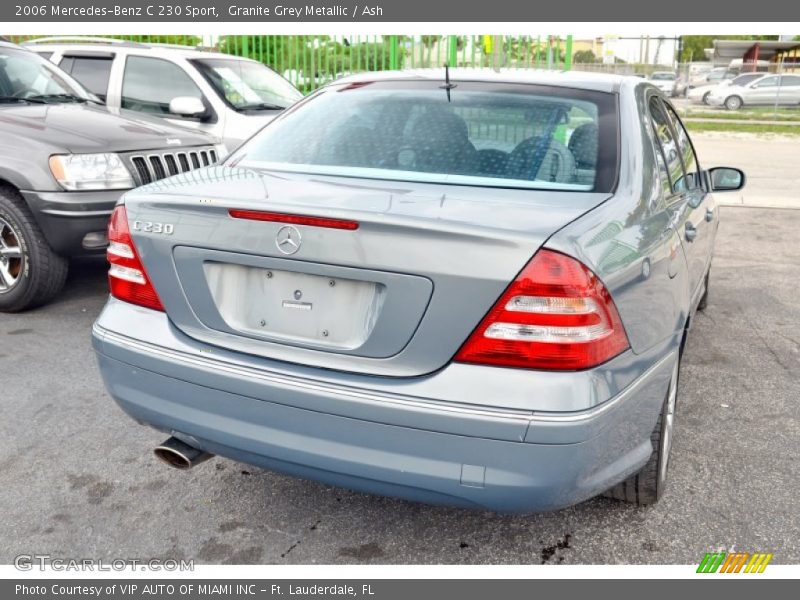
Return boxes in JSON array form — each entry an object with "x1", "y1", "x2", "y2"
[{"x1": 126, "y1": 167, "x2": 609, "y2": 376}]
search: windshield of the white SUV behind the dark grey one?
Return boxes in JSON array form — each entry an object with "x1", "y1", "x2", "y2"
[{"x1": 190, "y1": 58, "x2": 303, "y2": 110}]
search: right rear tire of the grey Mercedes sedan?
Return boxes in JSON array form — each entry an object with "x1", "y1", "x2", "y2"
[{"x1": 604, "y1": 357, "x2": 680, "y2": 506}]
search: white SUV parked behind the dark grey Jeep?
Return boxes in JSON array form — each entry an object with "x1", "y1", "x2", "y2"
[{"x1": 26, "y1": 37, "x2": 302, "y2": 151}]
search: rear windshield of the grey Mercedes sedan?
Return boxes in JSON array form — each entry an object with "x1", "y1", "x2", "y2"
[{"x1": 227, "y1": 81, "x2": 617, "y2": 192}]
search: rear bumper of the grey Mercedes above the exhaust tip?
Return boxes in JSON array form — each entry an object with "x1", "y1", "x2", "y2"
[{"x1": 93, "y1": 300, "x2": 675, "y2": 512}]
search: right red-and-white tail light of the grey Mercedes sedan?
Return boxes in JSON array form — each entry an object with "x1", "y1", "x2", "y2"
[{"x1": 455, "y1": 250, "x2": 628, "y2": 371}]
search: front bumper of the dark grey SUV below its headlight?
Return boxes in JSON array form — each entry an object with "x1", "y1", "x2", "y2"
[{"x1": 22, "y1": 190, "x2": 125, "y2": 256}]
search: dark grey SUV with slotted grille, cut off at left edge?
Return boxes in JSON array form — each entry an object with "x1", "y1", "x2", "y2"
[{"x1": 0, "y1": 42, "x2": 221, "y2": 311}]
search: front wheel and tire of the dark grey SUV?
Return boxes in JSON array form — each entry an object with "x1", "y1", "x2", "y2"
[{"x1": 0, "y1": 187, "x2": 68, "y2": 312}]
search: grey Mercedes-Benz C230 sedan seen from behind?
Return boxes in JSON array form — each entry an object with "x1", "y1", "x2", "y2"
[{"x1": 93, "y1": 69, "x2": 744, "y2": 512}]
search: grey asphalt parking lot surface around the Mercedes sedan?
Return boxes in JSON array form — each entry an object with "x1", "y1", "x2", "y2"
[{"x1": 0, "y1": 207, "x2": 800, "y2": 564}]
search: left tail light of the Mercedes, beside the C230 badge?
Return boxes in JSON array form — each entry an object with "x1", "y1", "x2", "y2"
[{"x1": 106, "y1": 206, "x2": 164, "y2": 311}]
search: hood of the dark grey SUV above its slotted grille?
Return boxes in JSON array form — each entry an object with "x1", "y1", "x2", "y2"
[{"x1": 0, "y1": 104, "x2": 216, "y2": 153}]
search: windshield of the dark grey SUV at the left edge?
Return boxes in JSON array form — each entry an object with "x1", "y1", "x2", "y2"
[{"x1": 0, "y1": 47, "x2": 97, "y2": 104}]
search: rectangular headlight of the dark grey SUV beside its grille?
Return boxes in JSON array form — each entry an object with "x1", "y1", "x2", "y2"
[{"x1": 50, "y1": 153, "x2": 135, "y2": 191}]
